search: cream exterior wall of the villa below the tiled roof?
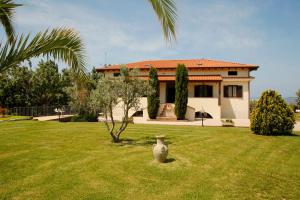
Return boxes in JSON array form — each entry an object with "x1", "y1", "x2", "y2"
[{"x1": 105, "y1": 70, "x2": 250, "y2": 120}]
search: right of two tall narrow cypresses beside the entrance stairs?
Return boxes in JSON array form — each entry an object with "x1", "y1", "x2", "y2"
[{"x1": 175, "y1": 64, "x2": 188, "y2": 120}]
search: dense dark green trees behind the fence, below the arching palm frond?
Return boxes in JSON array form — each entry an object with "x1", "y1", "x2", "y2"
[{"x1": 0, "y1": 61, "x2": 72, "y2": 108}]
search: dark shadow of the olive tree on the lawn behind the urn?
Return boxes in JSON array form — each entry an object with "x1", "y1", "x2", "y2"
[{"x1": 118, "y1": 136, "x2": 172, "y2": 146}]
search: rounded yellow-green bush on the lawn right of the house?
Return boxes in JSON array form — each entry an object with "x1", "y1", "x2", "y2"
[{"x1": 251, "y1": 90, "x2": 295, "y2": 135}]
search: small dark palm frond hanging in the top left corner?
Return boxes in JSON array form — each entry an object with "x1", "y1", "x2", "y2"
[{"x1": 0, "y1": 0, "x2": 21, "y2": 42}]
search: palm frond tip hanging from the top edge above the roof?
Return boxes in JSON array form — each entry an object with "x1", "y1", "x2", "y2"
[{"x1": 148, "y1": 0, "x2": 177, "y2": 42}]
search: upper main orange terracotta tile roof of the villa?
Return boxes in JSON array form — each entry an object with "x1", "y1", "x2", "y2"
[{"x1": 97, "y1": 59, "x2": 258, "y2": 71}]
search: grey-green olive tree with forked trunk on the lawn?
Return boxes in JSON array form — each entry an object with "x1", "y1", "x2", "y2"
[{"x1": 90, "y1": 66, "x2": 151, "y2": 143}]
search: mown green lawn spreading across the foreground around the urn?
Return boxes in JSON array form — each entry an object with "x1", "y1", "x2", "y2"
[{"x1": 0, "y1": 121, "x2": 300, "y2": 200}]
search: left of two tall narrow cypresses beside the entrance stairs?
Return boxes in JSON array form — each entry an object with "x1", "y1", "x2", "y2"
[{"x1": 147, "y1": 67, "x2": 160, "y2": 119}]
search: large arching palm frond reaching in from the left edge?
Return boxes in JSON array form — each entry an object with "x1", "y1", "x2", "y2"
[{"x1": 0, "y1": 28, "x2": 86, "y2": 73}]
